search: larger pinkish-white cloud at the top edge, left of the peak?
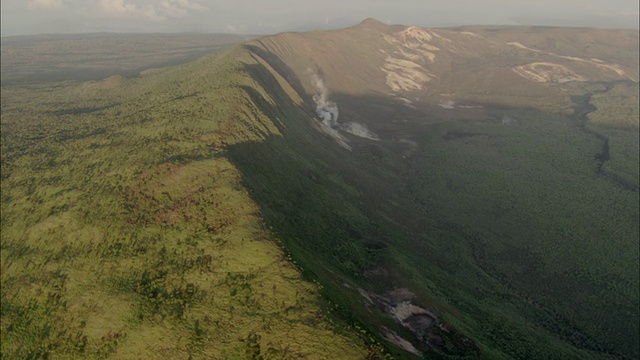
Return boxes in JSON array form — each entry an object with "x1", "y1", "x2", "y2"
[{"x1": 96, "y1": 0, "x2": 208, "y2": 21}]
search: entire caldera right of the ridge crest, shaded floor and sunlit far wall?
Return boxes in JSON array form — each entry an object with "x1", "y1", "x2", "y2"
[{"x1": 224, "y1": 20, "x2": 639, "y2": 358}]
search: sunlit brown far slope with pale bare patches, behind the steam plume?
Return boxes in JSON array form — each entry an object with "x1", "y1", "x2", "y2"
[{"x1": 252, "y1": 20, "x2": 638, "y2": 111}]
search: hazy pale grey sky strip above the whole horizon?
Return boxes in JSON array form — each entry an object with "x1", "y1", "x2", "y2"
[{"x1": 1, "y1": 0, "x2": 638, "y2": 36}]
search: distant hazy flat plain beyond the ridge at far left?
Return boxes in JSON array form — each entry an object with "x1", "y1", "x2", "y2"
[{"x1": 0, "y1": 33, "x2": 253, "y2": 85}]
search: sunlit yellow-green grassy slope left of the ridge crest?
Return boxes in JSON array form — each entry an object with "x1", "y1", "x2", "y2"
[{"x1": 0, "y1": 46, "x2": 376, "y2": 359}]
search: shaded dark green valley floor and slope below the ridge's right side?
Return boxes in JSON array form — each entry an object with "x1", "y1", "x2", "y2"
[{"x1": 222, "y1": 41, "x2": 639, "y2": 358}]
